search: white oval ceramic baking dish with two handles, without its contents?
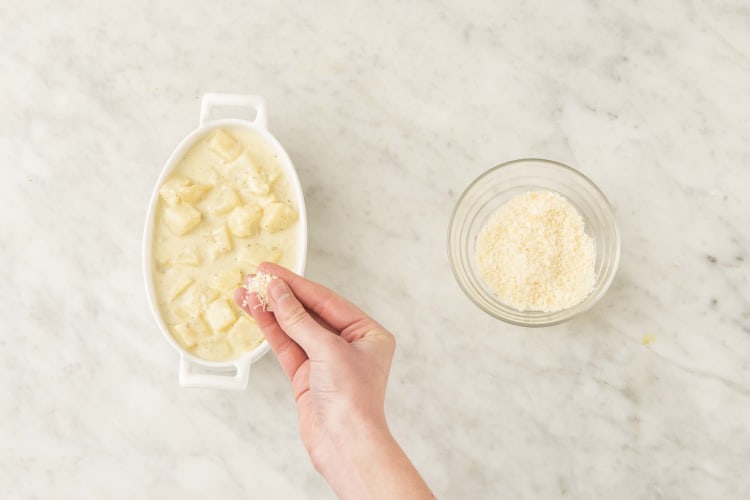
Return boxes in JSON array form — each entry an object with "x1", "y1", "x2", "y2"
[{"x1": 143, "y1": 94, "x2": 307, "y2": 390}]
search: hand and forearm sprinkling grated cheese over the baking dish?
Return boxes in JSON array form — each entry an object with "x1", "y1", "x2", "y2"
[{"x1": 235, "y1": 263, "x2": 433, "y2": 499}]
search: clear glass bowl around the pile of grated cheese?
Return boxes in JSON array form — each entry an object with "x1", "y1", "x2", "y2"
[{"x1": 448, "y1": 158, "x2": 620, "y2": 326}]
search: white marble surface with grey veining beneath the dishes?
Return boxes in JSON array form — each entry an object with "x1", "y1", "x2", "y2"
[{"x1": 0, "y1": 0, "x2": 750, "y2": 500}]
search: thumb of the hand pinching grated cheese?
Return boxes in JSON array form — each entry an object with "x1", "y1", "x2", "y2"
[{"x1": 268, "y1": 278, "x2": 337, "y2": 356}]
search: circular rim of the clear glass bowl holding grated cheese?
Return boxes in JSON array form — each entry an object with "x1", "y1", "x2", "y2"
[{"x1": 448, "y1": 158, "x2": 621, "y2": 327}]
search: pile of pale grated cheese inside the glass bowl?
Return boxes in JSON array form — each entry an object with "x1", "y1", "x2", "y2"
[{"x1": 475, "y1": 191, "x2": 596, "y2": 312}]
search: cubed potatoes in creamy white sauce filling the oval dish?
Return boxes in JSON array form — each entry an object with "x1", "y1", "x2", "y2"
[{"x1": 152, "y1": 127, "x2": 298, "y2": 361}]
